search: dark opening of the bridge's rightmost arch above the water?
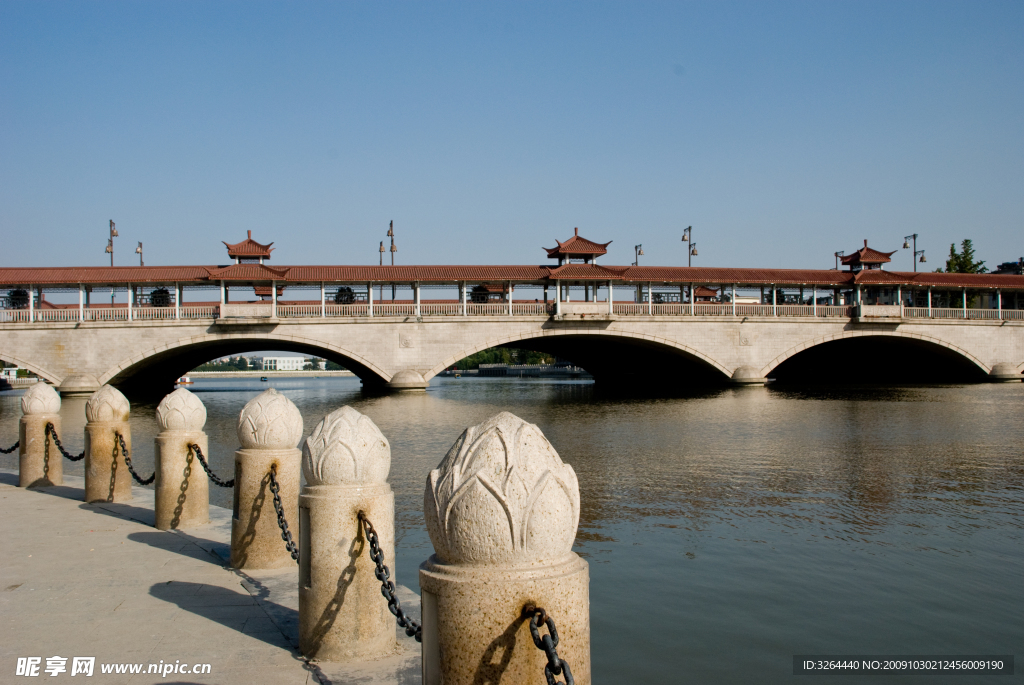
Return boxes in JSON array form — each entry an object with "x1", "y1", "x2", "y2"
[{"x1": 768, "y1": 335, "x2": 987, "y2": 385}]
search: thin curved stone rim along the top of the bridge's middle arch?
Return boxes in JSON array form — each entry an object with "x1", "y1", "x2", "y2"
[{"x1": 424, "y1": 328, "x2": 731, "y2": 381}]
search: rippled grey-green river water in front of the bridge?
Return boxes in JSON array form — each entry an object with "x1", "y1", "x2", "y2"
[{"x1": 0, "y1": 378, "x2": 1024, "y2": 685}]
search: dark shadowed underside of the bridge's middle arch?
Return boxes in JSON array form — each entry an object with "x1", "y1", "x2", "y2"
[{"x1": 435, "y1": 334, "x2": 729, "y2": 393}]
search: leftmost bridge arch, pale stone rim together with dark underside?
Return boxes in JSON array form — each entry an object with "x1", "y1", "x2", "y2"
[{"x1": 99, "y1": 333, "x2": 391, "y2": 391}]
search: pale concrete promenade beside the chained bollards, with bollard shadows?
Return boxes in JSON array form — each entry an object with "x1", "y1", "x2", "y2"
[{"x1": 0, "y1": 469, "x2": 421, "y2": 685}]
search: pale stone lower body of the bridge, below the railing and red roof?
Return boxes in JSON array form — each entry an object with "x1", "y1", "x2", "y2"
[{"x1": 0, "y1": 314, "x2": 1024, "y2": 396}]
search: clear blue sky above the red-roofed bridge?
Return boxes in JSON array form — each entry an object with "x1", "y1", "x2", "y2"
[{"x1": 0, "y1": 1, "x2": 1024, "y2": 270}]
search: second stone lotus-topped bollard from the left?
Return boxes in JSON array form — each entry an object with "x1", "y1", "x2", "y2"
[{"x1": 85, "y1": 385, "x2": 131, "y2": 502}]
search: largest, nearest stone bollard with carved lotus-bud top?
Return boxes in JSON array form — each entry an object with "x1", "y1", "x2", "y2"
[{"x1": 420, "y1": 412, "x2": 591, "y2": 685}]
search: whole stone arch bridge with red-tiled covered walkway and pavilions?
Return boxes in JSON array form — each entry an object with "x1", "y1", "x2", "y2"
[{"x1": 0, "y1": 253, "x2": 1024, "y2": 394}]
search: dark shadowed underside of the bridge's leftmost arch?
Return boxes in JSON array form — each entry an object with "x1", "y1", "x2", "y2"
[{"x1": 101, "y1": 338, "x2": 387, "y2": 397}]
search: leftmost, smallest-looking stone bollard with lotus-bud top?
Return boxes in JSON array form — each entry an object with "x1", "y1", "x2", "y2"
[{"x1": 17, "y1": 383, "x2": 63, "y2": 487}]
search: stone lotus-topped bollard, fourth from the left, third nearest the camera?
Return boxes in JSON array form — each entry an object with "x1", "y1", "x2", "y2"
[{"x1": 231, "y1": 388, "x2": 302, "y2": 568}]
